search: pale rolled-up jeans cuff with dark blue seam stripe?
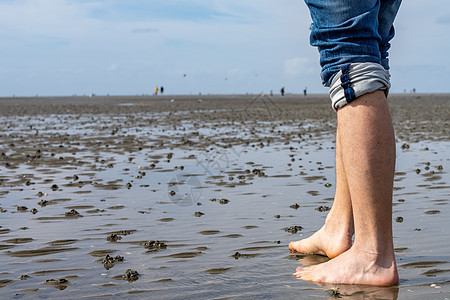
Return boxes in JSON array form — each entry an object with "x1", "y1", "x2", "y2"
[{"x1": 330, "y1": 62, "x2": 391, "y2": 111}]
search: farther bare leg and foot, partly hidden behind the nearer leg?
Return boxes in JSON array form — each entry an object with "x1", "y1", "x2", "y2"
[{"x1": 289, "y1": 126, "x2": 354, "y2": 258}]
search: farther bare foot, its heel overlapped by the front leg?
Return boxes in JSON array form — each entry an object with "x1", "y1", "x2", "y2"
[{"x1": 289, "y1": 224, "x2": 353, "y2": 258}]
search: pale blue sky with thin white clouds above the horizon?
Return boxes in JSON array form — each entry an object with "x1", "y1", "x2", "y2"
[{"x1": 0, "y1": 0, "x2": 450, "y2": 97}]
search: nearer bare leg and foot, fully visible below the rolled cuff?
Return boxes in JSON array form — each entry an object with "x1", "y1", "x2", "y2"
[{"x1": 294, "y1": 91, "x2": 398, "y2": 286}]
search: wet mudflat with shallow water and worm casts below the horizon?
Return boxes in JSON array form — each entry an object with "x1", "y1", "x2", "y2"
[{"x1": 0, "y1": 95, "x2": 450, "y2": 299}]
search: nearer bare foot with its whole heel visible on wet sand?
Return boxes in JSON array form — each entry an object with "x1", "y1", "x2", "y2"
[{"x1": 293, "y1": 247, "x2": 399, "y2": 286}]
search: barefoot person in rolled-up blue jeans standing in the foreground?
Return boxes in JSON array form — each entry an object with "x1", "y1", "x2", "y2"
[{"x1": 289, "y1": 0, "x2": 401, "y2": 286}]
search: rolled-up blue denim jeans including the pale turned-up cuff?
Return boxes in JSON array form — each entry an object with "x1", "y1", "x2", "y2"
[{"x1": 305, "y1": 0, "x2": 401, "y2": 110}]
